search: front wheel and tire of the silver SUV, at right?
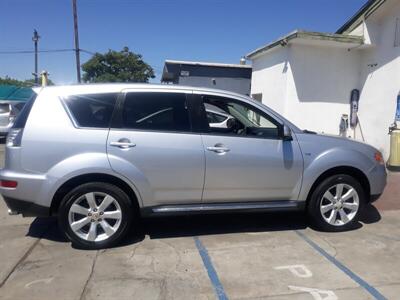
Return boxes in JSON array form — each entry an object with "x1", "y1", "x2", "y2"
[{"x1": 307, "y1": 174, "x2": 366, "y2": 232}]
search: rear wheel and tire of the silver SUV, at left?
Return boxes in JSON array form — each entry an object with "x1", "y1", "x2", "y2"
[{"x1": 58, "y1": 182, "x2": 134, "y2": 249}]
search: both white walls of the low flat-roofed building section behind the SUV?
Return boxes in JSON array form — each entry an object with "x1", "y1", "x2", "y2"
[{"x1": 251, "y1": 45, "x2": 359, "y2": 134}]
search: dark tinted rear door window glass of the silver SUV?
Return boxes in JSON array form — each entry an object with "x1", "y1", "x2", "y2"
[{"x1": 122, "y1": 93, "x2": 190, "y2": 131}]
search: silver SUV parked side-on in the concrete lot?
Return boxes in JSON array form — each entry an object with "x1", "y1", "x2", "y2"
[{"x1": 0, "y1": 84, "x2": 386, "y2": 249}]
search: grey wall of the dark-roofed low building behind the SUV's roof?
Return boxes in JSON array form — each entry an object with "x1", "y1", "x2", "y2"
[{"x1": 179, "y1": 76, "x2": 251, "y2": 95}]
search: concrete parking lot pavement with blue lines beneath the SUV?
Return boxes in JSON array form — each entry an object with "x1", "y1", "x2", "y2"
[{"x1": 0, "y1": 144, "x2": 400, "y2": 299}]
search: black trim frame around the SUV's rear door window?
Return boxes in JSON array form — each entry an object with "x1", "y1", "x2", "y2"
[{"x1": 110, "y1": 89, "x2": 196, "y2": 134}]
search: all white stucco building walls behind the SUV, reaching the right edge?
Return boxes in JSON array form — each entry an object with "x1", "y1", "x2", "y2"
[{"x1": 251, "y1": 0, "x2": 400, "y2": 159}]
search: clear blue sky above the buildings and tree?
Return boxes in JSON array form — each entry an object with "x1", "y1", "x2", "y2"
[{"x1": 0, "y1": 0, "x2": 366, "y2": 84}]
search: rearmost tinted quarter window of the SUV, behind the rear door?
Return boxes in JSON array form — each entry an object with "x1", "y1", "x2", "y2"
[{"x1": 64, "y1": 93, "x2": 117, "y2": 128}]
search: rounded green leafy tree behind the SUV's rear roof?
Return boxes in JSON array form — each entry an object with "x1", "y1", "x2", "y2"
[{"x1": 82, "y1": 47, "x2": 155, "y2": 82}]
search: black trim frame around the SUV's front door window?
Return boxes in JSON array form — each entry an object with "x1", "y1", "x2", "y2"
[{"x1": 193, "y1": 93, "x2": 284, "y2": 140}]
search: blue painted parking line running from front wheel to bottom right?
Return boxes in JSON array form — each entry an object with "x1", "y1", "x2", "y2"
[{"x1": 295, "y1": 230, "x2": 386, "y2": 300}]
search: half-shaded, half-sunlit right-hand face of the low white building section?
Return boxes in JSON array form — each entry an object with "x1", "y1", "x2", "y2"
[{"x1": 284, "y1": 45, "x2": 359, "y2": 134}]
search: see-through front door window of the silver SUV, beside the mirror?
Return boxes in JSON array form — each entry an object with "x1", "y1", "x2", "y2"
[{"x1": 203, "y1": 96, "x2": 280, "y2": 138}]
